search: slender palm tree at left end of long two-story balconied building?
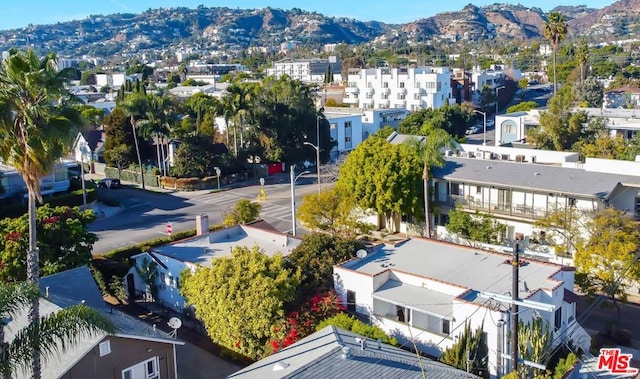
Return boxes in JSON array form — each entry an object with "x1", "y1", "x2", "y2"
[{"x1": 409, "y1": 128, "x2": 452, "y2": 238}]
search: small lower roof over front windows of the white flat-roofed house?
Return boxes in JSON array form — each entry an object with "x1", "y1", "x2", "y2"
[{"x1": 372, "y1": 280, "x2": 454, "y2": 319}]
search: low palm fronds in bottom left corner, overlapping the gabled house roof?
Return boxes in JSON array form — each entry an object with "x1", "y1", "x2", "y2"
[{"x1": 0, "y1": 282, "x2": 113, "y2": 378}]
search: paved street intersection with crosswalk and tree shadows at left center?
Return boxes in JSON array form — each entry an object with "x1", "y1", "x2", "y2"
[{"x1": 89, "y1": 175, "x2": 317, "y2": 255}]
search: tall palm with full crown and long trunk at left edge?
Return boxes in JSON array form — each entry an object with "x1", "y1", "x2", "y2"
[{"x1": 0, "y1": 50, "x2": 82, "y2": 377}]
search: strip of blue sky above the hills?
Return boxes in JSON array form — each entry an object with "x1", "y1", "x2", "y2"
[{"x1": 0, "y1": 0, "x2": 614, "y2": 30}]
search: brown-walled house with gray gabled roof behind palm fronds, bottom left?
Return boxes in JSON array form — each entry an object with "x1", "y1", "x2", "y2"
[{"x1": 5, "y1": 266, "x2": 184, "y2": 379}]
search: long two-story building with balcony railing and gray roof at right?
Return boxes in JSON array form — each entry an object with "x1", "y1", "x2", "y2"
[{"x1": 433, "y1": 156, "x2": 640, "y2": 251}]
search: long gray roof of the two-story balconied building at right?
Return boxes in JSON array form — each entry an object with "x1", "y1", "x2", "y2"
[{"x1": 433, "y1": 157, "x2": 640, "y2": 199}]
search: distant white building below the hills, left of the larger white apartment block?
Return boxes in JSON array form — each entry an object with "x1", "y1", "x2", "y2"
[{"x1": 267, "y1": 56, "x2": 342, "y2": 83}]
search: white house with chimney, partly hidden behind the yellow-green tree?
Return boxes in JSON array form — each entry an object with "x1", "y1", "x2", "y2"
[{"x1": 125, "y1": 221, "x2": 301, "y2": 313}]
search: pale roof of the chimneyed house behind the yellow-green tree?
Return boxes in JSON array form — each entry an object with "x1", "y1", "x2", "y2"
[{"x1": 151, "y1": 224, "x2": 301, "y2": 267}]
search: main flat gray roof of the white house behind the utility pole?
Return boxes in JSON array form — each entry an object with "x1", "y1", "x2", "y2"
[{"x1": 338, "y1": 238, "x2": 562, "y2": 298}]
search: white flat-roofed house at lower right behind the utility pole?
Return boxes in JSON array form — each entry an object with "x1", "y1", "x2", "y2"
[{"x1": 333, "y1": 238, "x2": 591, "y2": 378}]
